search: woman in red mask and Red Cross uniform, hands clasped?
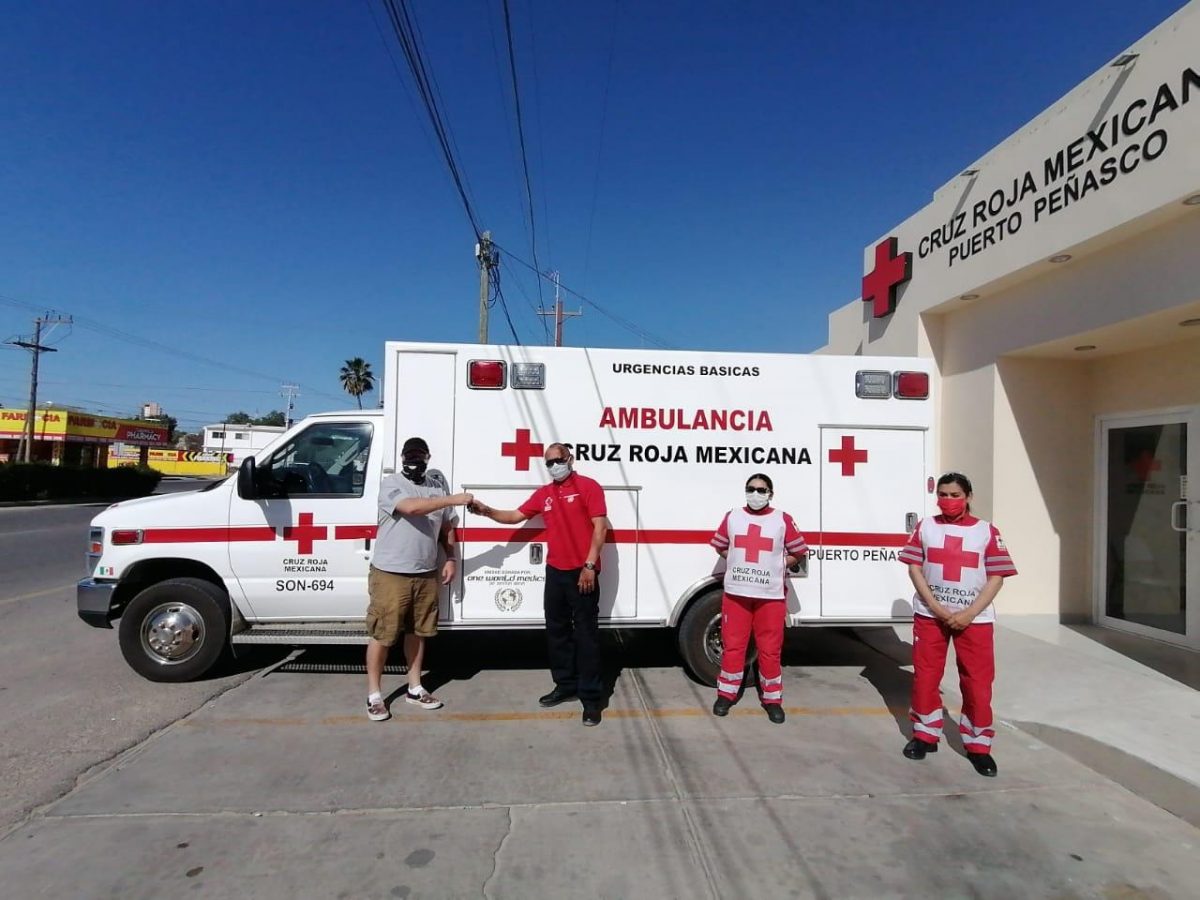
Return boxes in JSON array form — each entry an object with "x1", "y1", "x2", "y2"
[{"x1": 900, "y1": 472, "x2": 1016, "y2": 778}]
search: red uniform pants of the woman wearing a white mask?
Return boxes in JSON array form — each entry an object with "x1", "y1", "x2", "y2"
[{"x1": 716, "y1": 594, "x2": 787, "y2": 703}]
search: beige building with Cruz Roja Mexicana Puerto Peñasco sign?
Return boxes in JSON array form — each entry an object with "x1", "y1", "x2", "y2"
[{"x1": 822, "y1": 0, "x2": 1200, "y2": 649}]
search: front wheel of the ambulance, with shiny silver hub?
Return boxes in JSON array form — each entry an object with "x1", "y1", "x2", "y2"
[{"x1": 119, "y1": 578, "x2": 229, "y2": 682}]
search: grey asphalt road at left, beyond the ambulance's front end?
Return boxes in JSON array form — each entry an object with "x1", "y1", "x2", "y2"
[{"x1": 0, "y1": 481, "x2": 272, "y2": 829}]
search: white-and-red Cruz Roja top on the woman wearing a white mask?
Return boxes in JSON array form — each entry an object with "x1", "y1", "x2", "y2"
[{"x1": 712, "y1": 508, "x2": 808, "y2": 600}]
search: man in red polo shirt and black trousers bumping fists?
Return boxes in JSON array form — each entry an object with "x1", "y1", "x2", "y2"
[{"x1": 468, "y1": 444, "x2": 608, "y2": 725}]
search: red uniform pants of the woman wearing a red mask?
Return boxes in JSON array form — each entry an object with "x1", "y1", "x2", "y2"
[{"x1": 908, "y1": 616, "x2": 996, "y2": 754}]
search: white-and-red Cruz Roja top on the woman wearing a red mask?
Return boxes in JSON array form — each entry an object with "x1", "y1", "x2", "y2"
[{"x1": 900, "y1": 516, "x2": 1016, "y2": 624}]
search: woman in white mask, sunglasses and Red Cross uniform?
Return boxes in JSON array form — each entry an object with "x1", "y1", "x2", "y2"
[{"x1": 710, "y1": 475, "x2": 809, "y2": 725}]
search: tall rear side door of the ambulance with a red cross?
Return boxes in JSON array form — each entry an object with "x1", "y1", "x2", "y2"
[{"x1": 809, "y1": 426, "x2": 929, "y2": 620}]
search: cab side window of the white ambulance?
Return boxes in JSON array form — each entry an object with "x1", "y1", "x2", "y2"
[{"x1": 264, "y1": 422, "x2": 372, "y2": 497}]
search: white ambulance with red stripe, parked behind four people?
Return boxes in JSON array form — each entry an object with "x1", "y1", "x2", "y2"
[{"x1": 78, "y1": 342, "x2": 935, "y2": 684}]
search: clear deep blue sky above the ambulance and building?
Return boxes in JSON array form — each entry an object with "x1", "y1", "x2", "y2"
[{"x1": 0, "y1": 0, "x2": 1183, "y2": 427}]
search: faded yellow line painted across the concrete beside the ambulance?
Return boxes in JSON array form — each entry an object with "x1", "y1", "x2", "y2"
[{"x1": 181, "y1": 707, "x2": 907, "y2": 727}]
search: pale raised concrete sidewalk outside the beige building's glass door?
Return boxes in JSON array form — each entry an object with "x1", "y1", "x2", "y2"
[{"x1": 858, "y1": 616, "x2": 1200, "y2": 827}]
